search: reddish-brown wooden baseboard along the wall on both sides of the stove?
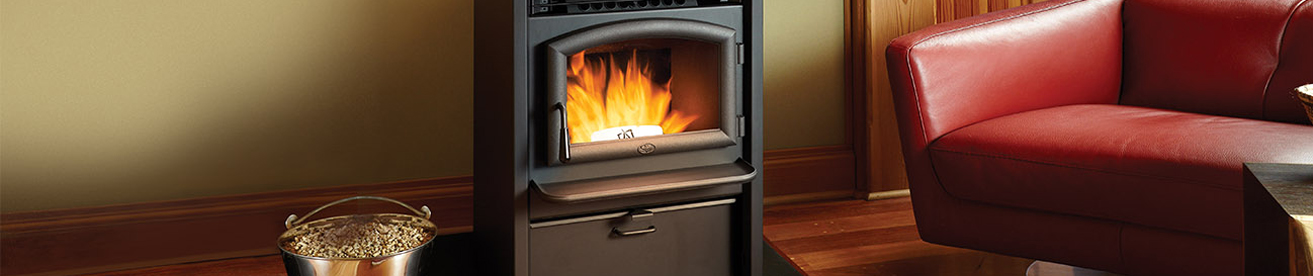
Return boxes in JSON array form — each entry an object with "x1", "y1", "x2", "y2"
[{"x1": 0, "y1": 147, "x2": 853, "y2": 275}]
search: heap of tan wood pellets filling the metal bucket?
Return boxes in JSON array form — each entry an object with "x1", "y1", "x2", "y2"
[{"x1": 282, "y1": 216, "x2": 433, "y2": 259}]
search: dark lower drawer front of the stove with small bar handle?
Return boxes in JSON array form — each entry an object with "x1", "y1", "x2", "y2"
[{"x1": 529, "y1": 200, "x2": 734, "y2": 276}]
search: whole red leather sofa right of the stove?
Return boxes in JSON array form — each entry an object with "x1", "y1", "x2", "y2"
[{"x1": 886, "y1": 0, "x2": 1313, "y2": 275}]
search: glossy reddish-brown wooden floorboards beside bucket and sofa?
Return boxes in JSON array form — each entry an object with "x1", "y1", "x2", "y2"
[{"x1": 87, "y1": 197, "x2": 1031, "y2": 276}]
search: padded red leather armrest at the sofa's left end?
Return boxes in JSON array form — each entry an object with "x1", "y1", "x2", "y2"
[{"x1": 885, "y1": 0, "x2": 1121, "y2": 147}]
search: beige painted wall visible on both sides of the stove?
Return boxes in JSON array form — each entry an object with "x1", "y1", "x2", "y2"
[{"x1": 0, "y1": 0, "x2": 843, "y2": 212}]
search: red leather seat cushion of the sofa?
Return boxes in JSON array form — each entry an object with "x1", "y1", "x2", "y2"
[{"x1": 930, "y1": 105, "x2": 1313, "y2": 241}]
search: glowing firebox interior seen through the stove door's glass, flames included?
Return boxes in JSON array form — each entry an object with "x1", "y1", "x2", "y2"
[{"x1": 566, "y1": 41, "x2": 718, "y2": 143}]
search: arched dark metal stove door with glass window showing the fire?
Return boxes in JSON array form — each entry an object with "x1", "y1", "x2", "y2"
[{"x1": 545, "y1": 18, "x2": 743, "y2": 166}]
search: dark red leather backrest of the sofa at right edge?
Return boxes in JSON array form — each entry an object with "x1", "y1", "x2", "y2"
[{"x1": 1120, "y1": 0, "x2": 1313, "y2": 124}]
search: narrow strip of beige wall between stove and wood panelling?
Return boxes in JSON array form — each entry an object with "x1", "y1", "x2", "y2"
[{"x1": 763, "y1": 0, "x2": 846, "y2": 150}]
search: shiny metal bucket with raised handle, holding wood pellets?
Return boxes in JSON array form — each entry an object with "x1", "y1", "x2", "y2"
[{"x1": 278, "y1": 196, "x2": 437, "y2": 276}]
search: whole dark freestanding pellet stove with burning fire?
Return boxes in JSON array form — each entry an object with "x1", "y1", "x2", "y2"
[{"x1": 474, "y1": 0, "x2": 762, "y2": 276}]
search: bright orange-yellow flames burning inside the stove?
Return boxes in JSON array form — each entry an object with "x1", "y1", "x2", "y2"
[{"x1": 566, "y1": 50, "x2": 697, "y2": 143}]
